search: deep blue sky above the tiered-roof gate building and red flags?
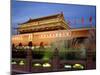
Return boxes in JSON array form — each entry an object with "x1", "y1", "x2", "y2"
[{"x1": 11, "y1": 0, "x2": 96, "y2": 34}]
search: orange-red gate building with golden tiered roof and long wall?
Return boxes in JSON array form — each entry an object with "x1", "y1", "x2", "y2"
[{"x1": 12, "y1": 13, "x2": 95, "y2": 49}]
